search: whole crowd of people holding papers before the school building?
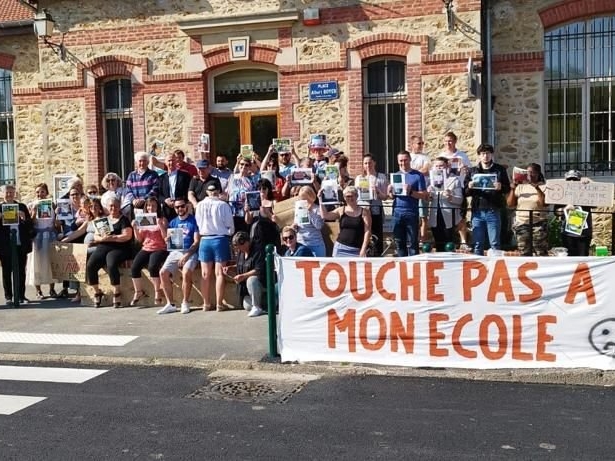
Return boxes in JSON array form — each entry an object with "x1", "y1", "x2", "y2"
[{"x1": 0, "y1": 132, "x2": 591, "y2": 310}]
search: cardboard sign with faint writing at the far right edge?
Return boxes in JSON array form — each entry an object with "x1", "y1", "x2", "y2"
[{"x1": 545, "y1": 179, "x2": 614, "y2": 207}]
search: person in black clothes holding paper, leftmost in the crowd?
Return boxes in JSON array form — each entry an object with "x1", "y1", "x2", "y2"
[{"x1": 0, "y1": 184, "x2": 35, "y2": 306}]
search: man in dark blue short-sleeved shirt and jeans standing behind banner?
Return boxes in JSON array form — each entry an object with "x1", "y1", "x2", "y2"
[{"x1": 388, "y1": 150, "x2": 429, "y2": 256}]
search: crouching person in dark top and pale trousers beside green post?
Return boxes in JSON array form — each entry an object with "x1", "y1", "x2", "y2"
[{"x1": 224, "y1": 231, "x2": 267, "y2": 317}]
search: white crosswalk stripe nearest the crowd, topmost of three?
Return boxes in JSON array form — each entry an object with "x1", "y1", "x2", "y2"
[{"x1": 0, "y1": 331, "x2": 138, "y2": 346}]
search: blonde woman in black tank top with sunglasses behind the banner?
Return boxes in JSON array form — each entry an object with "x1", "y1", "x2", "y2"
[{"x1": 319, "y1": 186, "x2": 372, "y2": 258}]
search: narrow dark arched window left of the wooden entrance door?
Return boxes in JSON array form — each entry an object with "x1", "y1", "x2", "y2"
[{"x1": 101, "y1": 78, "x2": 134, "y2": 179}]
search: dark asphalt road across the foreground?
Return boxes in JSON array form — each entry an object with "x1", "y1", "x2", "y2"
[{"x1": 0, "y1": 362, "x2": 615, "y2": 461}]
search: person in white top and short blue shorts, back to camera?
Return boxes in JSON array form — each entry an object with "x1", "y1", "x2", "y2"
[{"x1": 195, "y1": 182, "x2": 235, "y2": 311}]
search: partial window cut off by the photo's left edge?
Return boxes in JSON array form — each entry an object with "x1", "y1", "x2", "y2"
[{"x1": 0, "y1": 69, "x2": 15, "y2": 184}]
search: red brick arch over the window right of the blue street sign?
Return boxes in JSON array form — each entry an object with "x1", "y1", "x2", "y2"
[{"x1": 347, "y1": 32, "x2": 427, "y2": 60}]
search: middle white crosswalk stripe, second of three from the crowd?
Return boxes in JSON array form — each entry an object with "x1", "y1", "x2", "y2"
[{"x1": 0, "y1": 365, "x2": 108, "y2": 384}]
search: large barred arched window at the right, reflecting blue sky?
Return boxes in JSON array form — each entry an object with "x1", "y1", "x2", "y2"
[{"x1": 545, "y1": 16, "x2": 615, "y2": 177}]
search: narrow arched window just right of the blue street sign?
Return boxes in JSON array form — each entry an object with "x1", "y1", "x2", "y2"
[{"x1": 363, "y1": 58, "x2": 407, "y2": 171}]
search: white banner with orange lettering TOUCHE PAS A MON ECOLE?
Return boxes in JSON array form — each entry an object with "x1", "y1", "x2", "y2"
[{"x1": 278, "y1": 254, "x2": 615, "y2": 370}]
